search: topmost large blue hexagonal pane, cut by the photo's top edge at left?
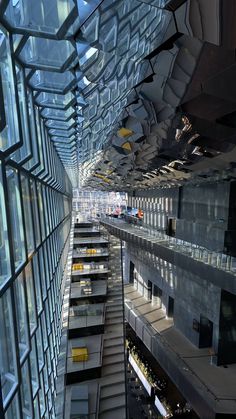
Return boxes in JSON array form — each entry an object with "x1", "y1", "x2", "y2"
[{"x1": 4, "y1": 0, "x2": 75, "y2": 35}]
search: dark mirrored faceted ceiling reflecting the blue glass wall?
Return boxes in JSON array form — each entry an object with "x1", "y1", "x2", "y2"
[{"x1": 0, "y1": 0, "x2": 236, "y2": 190}]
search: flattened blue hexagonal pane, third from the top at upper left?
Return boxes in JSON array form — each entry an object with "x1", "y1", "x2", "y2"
[{"x1": 29, "y1": 70, "x2": 75, "y2": 93}]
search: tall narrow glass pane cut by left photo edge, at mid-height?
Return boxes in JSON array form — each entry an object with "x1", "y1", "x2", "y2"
[{"x1": 0, "y1": 163, "x2": 10, "y2": 285}]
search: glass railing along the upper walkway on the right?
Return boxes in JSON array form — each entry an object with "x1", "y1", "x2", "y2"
[{"x1": 101, "y1": 217, "x2": 236, "y2": 275}]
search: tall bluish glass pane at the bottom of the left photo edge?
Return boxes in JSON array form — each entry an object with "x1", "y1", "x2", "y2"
[{"x1": 0, "y1": 291, "x2": 17, "y2": 402}]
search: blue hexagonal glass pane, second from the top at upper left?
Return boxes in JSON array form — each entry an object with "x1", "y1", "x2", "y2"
[{"x1": 19, "y1": 36, "x2": 75, "y2": 70}]
